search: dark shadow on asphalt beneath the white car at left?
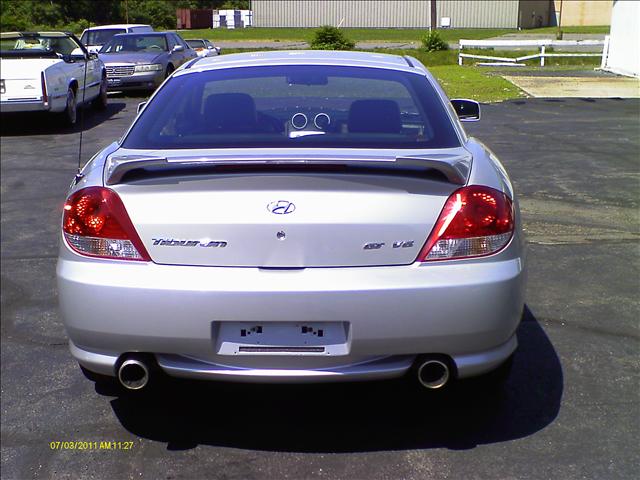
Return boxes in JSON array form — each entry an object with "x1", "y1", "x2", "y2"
[{"x1": 0, "y1": 101, "x2": 127, "y2": 137}]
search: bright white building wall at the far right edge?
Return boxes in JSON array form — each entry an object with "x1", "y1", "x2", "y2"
[{"x1": 604, "y1": 0, "x2": 640, "y2": 77}]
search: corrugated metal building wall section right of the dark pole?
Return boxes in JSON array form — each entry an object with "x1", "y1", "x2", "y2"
[{"x1": 438, "y1": 0, "x2": 519, "y2": 28}]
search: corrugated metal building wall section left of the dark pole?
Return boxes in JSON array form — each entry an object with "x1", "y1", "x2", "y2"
[{"x1": 251, "y1": 0, "x2": 430, "y2": 28}]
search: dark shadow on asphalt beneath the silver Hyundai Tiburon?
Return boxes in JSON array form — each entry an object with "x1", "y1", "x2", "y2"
[{"x1": 96, "y1": 308, "x2": 563, "y2": 452}]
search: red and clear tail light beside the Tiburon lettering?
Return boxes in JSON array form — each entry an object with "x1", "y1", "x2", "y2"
[{"x1": 62, "y1": 187, "x2": 151, "y2": 261}]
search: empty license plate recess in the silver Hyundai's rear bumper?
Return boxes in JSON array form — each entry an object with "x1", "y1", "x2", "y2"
[{"x1": 213, "y1": 322, "x2": 349, "y2": 356}]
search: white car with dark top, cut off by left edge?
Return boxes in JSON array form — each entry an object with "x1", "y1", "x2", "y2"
[{"x1": 0, "y1": 32, "x2": 107, "y2": 124}]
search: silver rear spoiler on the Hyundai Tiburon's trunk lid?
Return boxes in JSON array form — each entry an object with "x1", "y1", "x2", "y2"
[{"x1": 105, "y1": 154, "x2": 471, "y2": 185}]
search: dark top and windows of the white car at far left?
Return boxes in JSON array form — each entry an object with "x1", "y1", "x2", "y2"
[{"x1": 0, "y1": 32, "x2": 83, "y2": 57}]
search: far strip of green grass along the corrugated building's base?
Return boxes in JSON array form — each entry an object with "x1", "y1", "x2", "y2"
[{"x1": 179, "y1": 26, "x2": 609, "y2": 43}]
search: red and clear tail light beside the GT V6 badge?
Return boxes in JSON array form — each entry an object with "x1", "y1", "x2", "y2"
[{"x1": 417, "y1": 185, "x2": 514, "y2": 262}]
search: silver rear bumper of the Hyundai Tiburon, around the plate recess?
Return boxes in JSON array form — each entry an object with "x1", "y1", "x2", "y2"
[{"x1": 57, "y1": 240, "x2": 524, "y2": 381}]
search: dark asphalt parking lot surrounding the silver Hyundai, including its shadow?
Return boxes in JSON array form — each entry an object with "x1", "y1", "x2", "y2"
[{"x1": 0, "y1": 96, "x2": 640, "y2": 479}]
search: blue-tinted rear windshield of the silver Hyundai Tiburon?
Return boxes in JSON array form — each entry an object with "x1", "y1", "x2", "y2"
[{"x1": 123, "y1": 65, "x2": 460, "y2": 149}]
